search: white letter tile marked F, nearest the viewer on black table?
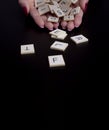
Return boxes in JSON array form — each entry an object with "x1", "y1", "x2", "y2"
[{"x1": 48, "y1": 55, "x2": 65, "y2": 67}]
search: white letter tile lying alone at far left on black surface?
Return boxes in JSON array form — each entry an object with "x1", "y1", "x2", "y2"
[{"x1": 20, "y1": 44, "x2": 35, "y2": 55}]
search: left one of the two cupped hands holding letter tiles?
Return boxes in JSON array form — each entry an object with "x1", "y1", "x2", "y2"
[{"x1": 18, "y1": 0, "x2": 59, "y2": 30}]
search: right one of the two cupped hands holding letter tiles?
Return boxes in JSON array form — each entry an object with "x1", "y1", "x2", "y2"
[{"x1": 61, "y1": 0, "x2": 89, "y2": 31}]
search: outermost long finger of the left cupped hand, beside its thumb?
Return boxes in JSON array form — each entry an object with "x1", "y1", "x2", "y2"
[{"x1": 30, "y1": 7, "x2": 44, "y2": 28}]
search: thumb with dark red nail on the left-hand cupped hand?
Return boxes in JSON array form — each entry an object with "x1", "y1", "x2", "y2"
[{"x1": 18, "y1": 0, "x2": 30, "y2": 15}]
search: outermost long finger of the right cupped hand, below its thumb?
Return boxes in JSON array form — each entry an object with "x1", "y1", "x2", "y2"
[{"x1": 74, "y1": 9, "x2": 83, "y2": 27}]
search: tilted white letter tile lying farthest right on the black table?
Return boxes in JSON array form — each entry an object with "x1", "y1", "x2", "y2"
[{"x1": 70, "y1": 34, "x2": 88, "y2": 44}]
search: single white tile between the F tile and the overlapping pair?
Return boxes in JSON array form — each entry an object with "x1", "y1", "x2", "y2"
[{"x1": 50, "y1": 41, "x2": 68, "y2": 51}]
